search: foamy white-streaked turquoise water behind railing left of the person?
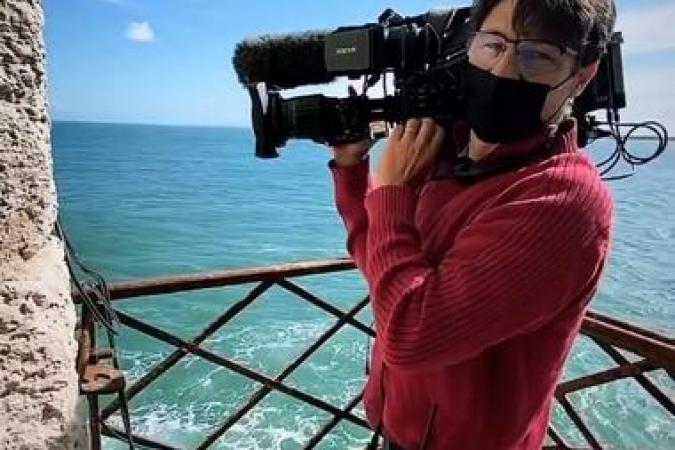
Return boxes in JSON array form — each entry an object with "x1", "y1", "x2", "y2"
[{"x1": 105, "y1": 320, "x2": 365, "y2": 449}]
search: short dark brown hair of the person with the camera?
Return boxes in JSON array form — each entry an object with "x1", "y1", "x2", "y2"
[{"x1": 472, "y1": 0, "x2": 616, "y2": 66}]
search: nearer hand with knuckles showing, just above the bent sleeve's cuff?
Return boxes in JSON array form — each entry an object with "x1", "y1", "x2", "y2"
[{"x1": 377, "y1": 118, "x2": 445, "y2": 186}]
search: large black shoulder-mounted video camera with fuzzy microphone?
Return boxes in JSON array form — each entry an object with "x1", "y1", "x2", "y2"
[{"x1": 233, "y1": 7, "x2": 626, "y2": 158}]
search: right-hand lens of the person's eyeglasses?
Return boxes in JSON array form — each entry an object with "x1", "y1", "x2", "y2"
[{"x1": 516, "y1": 41, "x2": 565, "y2": 81}]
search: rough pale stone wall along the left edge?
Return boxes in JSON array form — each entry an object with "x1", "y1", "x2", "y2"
[{"x1": 0, "y1": 0, "x2": 84, "y2": 449}]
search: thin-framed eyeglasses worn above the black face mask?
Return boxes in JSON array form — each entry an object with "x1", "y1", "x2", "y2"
[{"x1": 467, "y1": 31, "x2": 579, "y2": 84}]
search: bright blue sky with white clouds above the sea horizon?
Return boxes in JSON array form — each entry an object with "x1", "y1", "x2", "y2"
[{"x1": 43, "y1": 0, "x2": 675, "y2": 134}]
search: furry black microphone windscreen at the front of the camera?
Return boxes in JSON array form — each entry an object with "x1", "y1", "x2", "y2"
[{"x1": 232, "y1": 31, "x2": 335, "y2": 89}]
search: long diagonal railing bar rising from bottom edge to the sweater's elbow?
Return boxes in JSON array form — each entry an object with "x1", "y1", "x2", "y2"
[{"x1": 197, "y1": 297, "x2": 370, "y2": 450}]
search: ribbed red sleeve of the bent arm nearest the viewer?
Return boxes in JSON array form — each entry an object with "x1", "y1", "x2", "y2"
[{"x1": 364, "y1": 163, "x2": 611, "y2": 370}]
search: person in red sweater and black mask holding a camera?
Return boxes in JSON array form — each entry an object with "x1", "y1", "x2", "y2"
[{"x1": 330, "y1": 0, "x2": 616, "y2": 450}]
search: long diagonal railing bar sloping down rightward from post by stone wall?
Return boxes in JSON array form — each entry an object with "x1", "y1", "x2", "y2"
[{"x1": 116, "y1": 311, "x2": 368, "y2": 427}]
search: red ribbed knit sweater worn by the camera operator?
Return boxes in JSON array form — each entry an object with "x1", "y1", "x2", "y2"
[{"x1": 331, "y1": 121, "x2": 612, "y2": 450}]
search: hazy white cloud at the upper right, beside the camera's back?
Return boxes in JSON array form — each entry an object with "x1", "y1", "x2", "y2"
[{"x1": 616, "y1": 2, "x2": 675, "y2": 54}]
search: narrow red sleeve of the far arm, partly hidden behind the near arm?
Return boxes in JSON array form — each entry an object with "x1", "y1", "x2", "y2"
[{"x1": 329, "y1": 158, "x2": 369, "y2": 274}]
